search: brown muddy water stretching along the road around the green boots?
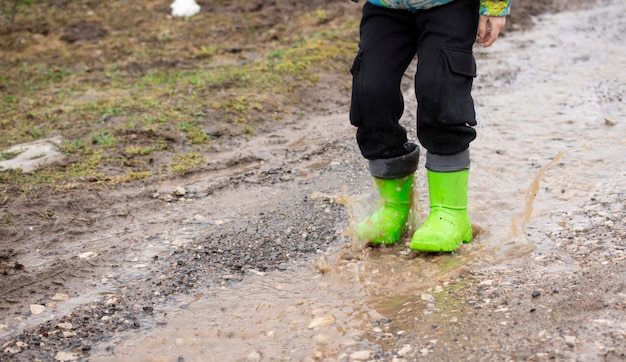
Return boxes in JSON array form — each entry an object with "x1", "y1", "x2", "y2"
[{"x1": 90, "y1": 0, "x2": 626, "y2": 362}]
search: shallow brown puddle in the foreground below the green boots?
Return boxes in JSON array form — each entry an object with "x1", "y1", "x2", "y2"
[{"x1": 90, "y1": 239, "x2": 490, "y2": 361}]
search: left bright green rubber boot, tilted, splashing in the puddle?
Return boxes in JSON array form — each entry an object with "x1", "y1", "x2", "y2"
[{"x1": 355, "y1": 174, "x2": 414, "y2": 244}]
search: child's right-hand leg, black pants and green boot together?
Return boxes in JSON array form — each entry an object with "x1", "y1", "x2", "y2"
[{"x1": 411, "y1": 0, "x2": 478, "y2": 252}]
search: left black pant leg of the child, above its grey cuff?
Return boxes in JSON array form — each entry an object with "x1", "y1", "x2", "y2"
[{"x1": 350, "y1": 3, "x2": 417, "y2": 160}]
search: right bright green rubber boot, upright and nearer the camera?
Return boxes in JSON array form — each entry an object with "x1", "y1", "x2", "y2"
[{"x1": 411, "y1": 170, "x2": 472, "y2": 252}]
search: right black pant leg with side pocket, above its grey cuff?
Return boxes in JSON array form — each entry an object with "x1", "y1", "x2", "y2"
[{"x1": 415, "y1": 0, "x2": 478, "y2": 159}]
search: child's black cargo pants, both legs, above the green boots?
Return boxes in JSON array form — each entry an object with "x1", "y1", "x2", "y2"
[{"x1": 350, "y1": 0, "x2": 479, "y2": 177}]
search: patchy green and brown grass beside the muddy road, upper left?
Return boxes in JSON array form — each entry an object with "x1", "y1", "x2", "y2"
[{"x1": 0, "y1": 0, "x2": 359, "y2": 185}]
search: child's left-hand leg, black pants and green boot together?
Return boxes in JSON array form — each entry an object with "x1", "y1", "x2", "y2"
[{"x1": 350, "y1": 4, "x2": 419, "y2": 244}]
